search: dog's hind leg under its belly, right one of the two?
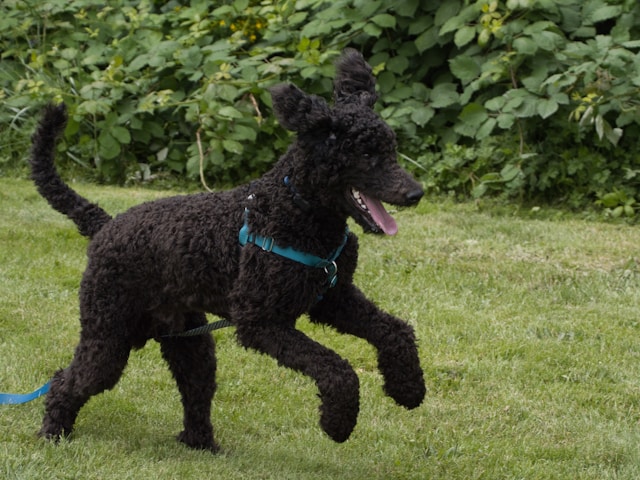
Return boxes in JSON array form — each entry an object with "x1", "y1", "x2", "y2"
[{"x1": 160, "y1": 313, "x2": 219, "y2": 452}]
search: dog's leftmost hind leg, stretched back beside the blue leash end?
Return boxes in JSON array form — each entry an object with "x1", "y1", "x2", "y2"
[{"x1": 39, "y1": 328, "x2": 131, "y2": 440}]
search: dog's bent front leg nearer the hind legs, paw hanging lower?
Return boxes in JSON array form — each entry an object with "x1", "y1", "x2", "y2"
[{"x1": 236, "y1": 315, "x2": 360, "y2": 442}]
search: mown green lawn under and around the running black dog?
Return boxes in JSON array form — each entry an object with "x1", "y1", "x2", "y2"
[{"x1": 0, "y1": 179, "x2": 640, "y2": 480}]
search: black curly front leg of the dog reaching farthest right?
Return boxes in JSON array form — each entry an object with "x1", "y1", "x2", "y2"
[{"x1": 310, "y1": 284, "x2": 426, "y2": 409}]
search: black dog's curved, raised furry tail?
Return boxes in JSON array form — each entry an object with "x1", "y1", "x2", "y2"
[{"x1": 30, "y1": 104, "x2": 111, "y2": 238}]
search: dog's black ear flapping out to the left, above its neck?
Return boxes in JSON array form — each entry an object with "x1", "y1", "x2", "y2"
[{"x1": 270, "y1": 84, "x2": 331, "y2": 133}]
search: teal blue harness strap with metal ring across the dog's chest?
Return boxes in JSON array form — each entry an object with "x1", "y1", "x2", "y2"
[{"x1": 238, "y1": 208, "x2": 349, "y2": 288}]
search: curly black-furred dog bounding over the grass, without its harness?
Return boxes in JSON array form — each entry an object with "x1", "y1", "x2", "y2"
[{"x1": 31, "y1": 50, "x2": 425, "y2": 451}]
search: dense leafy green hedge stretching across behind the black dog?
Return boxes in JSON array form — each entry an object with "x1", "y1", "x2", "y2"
[{"x1": 0, "y1": 0, "x2": 640, "y2": 211}]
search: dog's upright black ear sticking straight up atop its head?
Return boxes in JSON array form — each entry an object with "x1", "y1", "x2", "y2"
[{"x1": 333, "y1": 48, "x2": 378, "y2": 107}]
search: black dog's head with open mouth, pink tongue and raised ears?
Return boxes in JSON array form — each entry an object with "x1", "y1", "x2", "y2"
[{"x1": 271, "y1": 49, "x2": 423, "y2": 235}]
